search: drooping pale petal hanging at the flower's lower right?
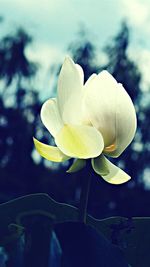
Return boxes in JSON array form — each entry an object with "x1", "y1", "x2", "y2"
[{"x1": 92, "y1": 155, "x2": 131, "y2": 184}]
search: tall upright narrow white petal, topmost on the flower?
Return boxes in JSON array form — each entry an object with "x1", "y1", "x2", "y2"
[{"x1": 57, "y1": 57, "x2": 83, "y2": 124}]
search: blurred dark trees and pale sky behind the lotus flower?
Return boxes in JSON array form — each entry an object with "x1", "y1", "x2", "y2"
[{"x1": 0, "y1": 0, "x2": 150, "y2": 218}]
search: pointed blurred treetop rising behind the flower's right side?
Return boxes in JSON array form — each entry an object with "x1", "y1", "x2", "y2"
[{"x1": 103, "y1": 22, "x2": 141, "y2": 103}]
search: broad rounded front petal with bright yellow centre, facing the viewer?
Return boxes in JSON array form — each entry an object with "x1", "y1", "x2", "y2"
[{"x1": 55, "y1": 125, "x2": 104, "y2": 159}]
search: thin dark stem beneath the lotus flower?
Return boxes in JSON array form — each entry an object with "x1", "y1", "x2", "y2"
[{"x1": 79, "y1": 165, "x2": 91, "y2": 224}]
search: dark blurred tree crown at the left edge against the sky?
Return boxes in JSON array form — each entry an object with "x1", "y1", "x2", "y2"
[{"x1": 0, "y1": 28, "x2": 37, "y2": 87}]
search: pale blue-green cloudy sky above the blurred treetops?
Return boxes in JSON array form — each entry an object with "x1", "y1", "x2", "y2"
[{"x1": 0, "y1": 0, "x2": 150, "y2": 93}]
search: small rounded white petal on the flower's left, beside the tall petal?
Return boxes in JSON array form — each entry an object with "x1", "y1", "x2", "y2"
[{"x1": 41, "y1": 98, "x2": 63, "y2": 136}]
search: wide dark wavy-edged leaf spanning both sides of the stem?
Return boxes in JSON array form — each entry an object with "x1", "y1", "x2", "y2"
[{"x1": 0, "y1": 194, "x2": 150, "y2": 267}]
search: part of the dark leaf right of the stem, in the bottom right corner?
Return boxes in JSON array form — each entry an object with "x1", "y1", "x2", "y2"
[{"x1": 88, "y1": 216, "x2": 150, "y2": 267}]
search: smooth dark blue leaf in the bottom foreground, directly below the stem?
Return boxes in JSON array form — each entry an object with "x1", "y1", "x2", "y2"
[{"x1": 55, "y1": 222, "x2": 128, "y2": 267}]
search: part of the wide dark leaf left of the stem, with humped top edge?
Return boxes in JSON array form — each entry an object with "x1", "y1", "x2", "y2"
[{"x1": 0, "y1": 193, "x2": 78, "y2": 245}]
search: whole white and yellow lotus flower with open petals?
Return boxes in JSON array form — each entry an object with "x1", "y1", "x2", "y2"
[{"x1": 34, "y1": 57, "x2": 136, "y2": 184}]
